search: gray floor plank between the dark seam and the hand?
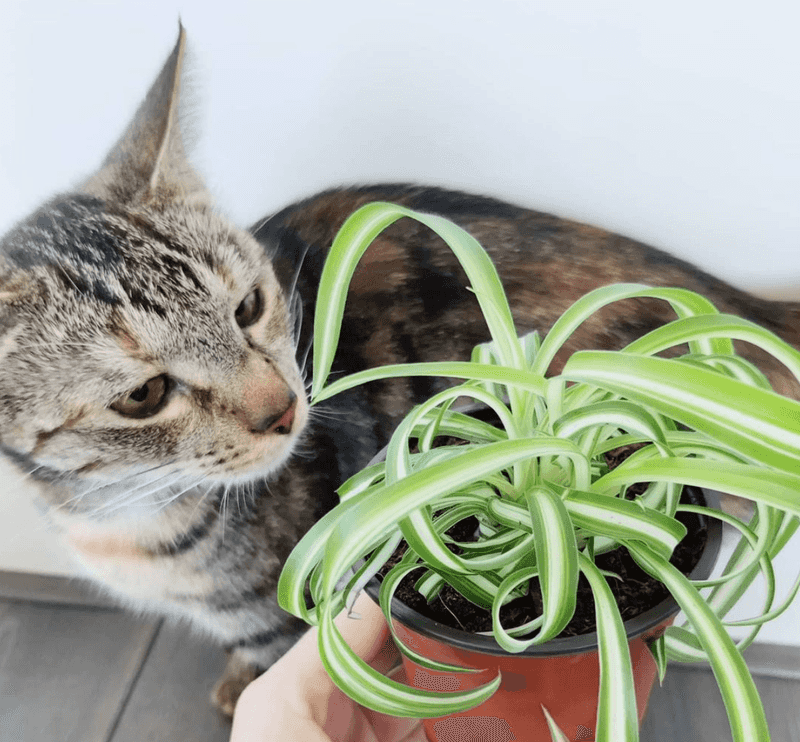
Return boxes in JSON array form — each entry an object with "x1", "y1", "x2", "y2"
[{"x1": 111, "y1": 625, "x2": 230, "y2": 742}]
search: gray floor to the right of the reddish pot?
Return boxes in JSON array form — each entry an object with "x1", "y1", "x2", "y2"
[{"x1": 641, "y1": 665, "x2": 800, "y2": 742}]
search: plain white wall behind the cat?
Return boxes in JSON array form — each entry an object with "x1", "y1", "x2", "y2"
[{"x1": 0, "y1": 0, "x2": 800, "y2": 643}]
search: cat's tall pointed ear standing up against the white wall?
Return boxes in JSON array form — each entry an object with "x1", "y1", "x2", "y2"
[{"x1": 82, "y1": 25, "x2": 210, "y2": 204}]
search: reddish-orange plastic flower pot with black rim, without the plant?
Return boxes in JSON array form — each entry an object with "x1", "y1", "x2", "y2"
[{"x1": 367, "y1": 491, "x2": 722, "y2": 742}]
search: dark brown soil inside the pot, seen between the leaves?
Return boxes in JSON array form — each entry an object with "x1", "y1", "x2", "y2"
[{"x1": 380, "y1": 438, "x2": 707, "y2": 637}]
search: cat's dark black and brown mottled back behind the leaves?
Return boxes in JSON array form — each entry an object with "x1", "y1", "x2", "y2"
[{"x1": 252, "y1": 184, "x2": 800, "y2": 404}]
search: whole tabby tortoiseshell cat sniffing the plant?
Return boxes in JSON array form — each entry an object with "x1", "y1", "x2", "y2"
[{"x1": 0, "y1": 29, "x2": 800, "y2": 714}]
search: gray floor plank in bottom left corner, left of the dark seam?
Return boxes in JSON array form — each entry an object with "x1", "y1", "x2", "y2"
[{"x1": 0, "y1": 601, "x2": 158, "y2": 742}]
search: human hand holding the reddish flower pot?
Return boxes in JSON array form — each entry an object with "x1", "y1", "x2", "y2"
[{"x1": 230, "y1": 594, "x2": 426, "y2": 742}]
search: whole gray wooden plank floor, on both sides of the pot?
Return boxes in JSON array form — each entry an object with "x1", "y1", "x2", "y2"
[{"x1": 0, "y1": 600, "x2": 800, "y2": 742}]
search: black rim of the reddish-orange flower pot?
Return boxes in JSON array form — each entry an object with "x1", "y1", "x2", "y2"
[{"x1": 364, "y1": 487, "x2": 722, "y2": 657}]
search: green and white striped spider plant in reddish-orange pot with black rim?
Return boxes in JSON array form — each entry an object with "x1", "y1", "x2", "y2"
[{"x1": 279, "y1": 204, "x2": 800, "y2": 742}]
